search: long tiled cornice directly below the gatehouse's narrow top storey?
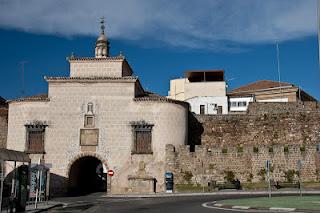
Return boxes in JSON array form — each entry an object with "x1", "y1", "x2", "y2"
[{"x1": 44, "y1": 76, "x2": 138, "y2": 81}]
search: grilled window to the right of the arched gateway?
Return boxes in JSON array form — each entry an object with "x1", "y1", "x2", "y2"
[{"x1": 131, "y1": 121, "x2": 153, "y2": 154}]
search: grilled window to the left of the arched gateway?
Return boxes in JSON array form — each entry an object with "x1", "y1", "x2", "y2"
[{"x1": 26, "y1": 125, "x2": 45, "y2": 153}]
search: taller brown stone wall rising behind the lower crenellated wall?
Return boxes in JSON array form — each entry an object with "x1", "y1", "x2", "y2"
[{"x1": 189, "y1": 102, "x2": 320, "y2": 146}]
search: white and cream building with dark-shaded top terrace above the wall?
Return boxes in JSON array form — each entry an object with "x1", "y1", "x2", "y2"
[{"x1": 168, "y1": 70, "x2": 228, "y2": 114}]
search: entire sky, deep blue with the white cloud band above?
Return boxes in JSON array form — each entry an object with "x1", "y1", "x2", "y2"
[{"x1": 0, "y1": 0, "x2": 320, "y2": 99}]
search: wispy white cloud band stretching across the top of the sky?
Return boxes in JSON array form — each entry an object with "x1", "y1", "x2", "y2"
[{"x1": 0, "y1": 0, "x2": 317, "y2": 49}]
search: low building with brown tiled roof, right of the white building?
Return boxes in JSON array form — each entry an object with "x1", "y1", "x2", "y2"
[{"x1": 228, "y1": 80, "x2": 317, "y2": 112}]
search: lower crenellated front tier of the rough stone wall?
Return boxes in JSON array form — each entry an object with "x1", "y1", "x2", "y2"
[{"x1": 166, "y1": 144, "x2": 320, "y2": 185}]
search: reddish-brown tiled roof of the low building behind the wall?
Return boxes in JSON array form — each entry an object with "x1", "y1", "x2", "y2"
[{"x1": 229, "y1": 80, "x2": 294, "y2": 93}]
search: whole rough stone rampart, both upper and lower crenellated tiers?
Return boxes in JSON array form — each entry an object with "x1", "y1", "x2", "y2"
[{"x1": 171, "y1": 102, "x2": 320, "y2": 184}]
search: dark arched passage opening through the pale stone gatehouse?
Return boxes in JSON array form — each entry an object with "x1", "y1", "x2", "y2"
[{"x1": 68, "y1": 156, "x2": 107, "y2": 196}]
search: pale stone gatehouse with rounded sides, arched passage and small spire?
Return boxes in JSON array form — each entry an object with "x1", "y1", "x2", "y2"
[{"x1": 7, "y1": 21, "x2": 189, "y2": 194}]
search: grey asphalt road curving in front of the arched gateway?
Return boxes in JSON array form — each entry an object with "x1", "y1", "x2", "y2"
[{"x1": 48, "y1": 194, "x2": 272, "y2": 213}]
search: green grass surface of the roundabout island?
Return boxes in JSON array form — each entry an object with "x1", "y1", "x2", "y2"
[{"x1": 219, "y1": 196, "x2": 320, "y2": 210}]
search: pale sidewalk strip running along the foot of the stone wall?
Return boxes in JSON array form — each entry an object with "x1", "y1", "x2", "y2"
[{"x1": 101, "y1": 190, "x2": 320, "y2": 198}]
